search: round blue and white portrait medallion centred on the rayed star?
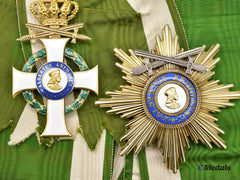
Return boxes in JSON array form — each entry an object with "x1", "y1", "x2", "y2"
[{"x1": 142, "y1": 70, "x2": 200, "y2": 128}]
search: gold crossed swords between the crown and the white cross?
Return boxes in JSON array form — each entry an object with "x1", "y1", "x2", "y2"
[{"x1": 17, "y1": 23, "x2": 91, "y2": 43}]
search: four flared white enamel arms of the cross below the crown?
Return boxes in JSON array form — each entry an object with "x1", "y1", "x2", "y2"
[{"x1": 12, "y1": 38, "x2": 98, "y2": 136}]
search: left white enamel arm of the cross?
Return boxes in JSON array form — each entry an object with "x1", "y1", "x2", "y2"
[{"x1": 12, "y1": 67, "x2": 37, "y2": 97}]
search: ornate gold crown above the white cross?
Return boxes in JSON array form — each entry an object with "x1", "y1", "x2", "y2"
[{"x1": 30, "y1": 0, "x2": 79, "y2": 26}]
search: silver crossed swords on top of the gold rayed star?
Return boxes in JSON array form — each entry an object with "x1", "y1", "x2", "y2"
[{"x1": 131, "y1": 47, "x2": 208, "y2": 76}]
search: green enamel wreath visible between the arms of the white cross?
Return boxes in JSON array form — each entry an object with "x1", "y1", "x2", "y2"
[{"x1": 22, "y1": 48, "x2": 89, "y2": 115}]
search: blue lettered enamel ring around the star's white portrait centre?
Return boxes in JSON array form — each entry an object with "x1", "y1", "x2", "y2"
[{"x1": 145, "y1": 72, "x2": 198, "y2": 125}]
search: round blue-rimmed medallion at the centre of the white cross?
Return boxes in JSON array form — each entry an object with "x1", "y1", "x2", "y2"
[{"x1": 36, "y1": 61, "x2": 74, "y2": 100}]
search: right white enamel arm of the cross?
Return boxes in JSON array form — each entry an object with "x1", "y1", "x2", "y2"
[{"x1": 74, "y1": 66, "x2": 98, "y2": 94}]
